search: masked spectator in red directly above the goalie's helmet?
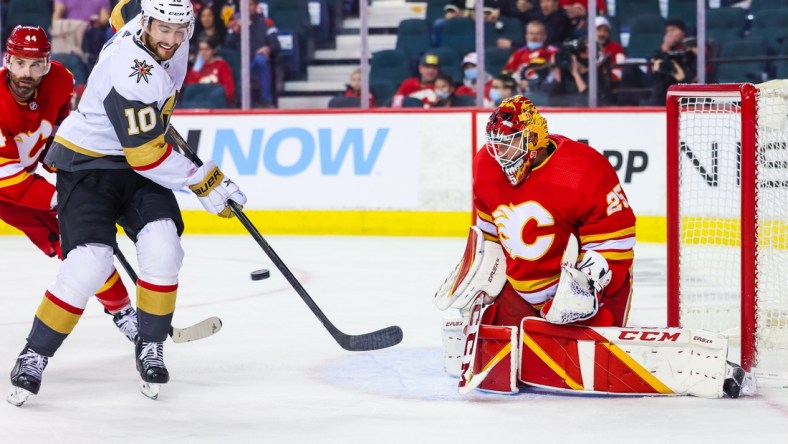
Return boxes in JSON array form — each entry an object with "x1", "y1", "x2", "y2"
[{"x1": 501, "y1": 20, "x2": 558, "y2": 93}]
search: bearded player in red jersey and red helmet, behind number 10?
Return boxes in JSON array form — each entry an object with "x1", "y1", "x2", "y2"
[{"x1": 0, "y1": 26, "x2": 137, "y2": 340}]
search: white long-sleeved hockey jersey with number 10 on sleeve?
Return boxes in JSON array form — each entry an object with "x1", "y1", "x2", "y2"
[{"x1": 46, "y1": 15, "x2": 192, "y2": 189}]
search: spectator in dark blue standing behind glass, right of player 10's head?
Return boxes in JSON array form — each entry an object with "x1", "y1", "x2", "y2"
[{"x1": 225, "y1": 0, "x2": 280, "y2": 108}]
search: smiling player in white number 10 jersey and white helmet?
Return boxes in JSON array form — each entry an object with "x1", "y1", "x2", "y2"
[{"x1": 8, "y1": 0, "x2": 246, "y2": 405}]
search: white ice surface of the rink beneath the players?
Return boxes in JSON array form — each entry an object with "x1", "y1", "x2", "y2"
[{"x1": 0, "y1": 234, "x2": 788, "y2": 444}]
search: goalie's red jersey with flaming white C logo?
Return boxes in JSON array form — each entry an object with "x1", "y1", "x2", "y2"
[{"x1": 473, "y1": 134, "x2": 635, "y2": 326}]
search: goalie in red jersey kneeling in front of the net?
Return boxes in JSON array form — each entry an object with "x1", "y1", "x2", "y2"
[{"x1": 434, "y1": 96, "x2": 744, "y2": 398}]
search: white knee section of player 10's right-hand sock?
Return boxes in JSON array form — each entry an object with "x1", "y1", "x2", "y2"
[{"x1": 137, "y1": 219, "x2": 183, "y2": 285}]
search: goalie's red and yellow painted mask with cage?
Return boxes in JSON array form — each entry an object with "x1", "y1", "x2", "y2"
[{"x1": 485, "y1": 95, "x2": 549, "y2": 186}]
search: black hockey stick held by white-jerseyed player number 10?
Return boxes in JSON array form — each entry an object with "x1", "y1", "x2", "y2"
[{"x1": 167, "y1": 126, "x2": 402, "y2": 351}]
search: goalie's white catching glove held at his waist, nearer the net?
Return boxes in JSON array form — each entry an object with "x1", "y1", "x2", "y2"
[{"x1": 542, "y1": 234, "x2": 613, "y2": 324}]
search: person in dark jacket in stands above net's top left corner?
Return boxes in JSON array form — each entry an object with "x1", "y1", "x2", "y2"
[{"x1": 651, "y1": 19, "x2": 697, "y2": 106}]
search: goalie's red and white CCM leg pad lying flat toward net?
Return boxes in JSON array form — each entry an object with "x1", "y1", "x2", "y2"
[{"x1": 520, "y1": 318, "x2": 728, "y2": 398}]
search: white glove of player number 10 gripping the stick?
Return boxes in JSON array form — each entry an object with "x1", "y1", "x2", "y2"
[{"x1": 186, "y1": 160, "x2": 246, "y2": 217}]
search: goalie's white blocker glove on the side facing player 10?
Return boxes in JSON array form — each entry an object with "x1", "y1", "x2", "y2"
[{"x1": 432, "y1": 226, "x2": 506, "y2": 310}]
